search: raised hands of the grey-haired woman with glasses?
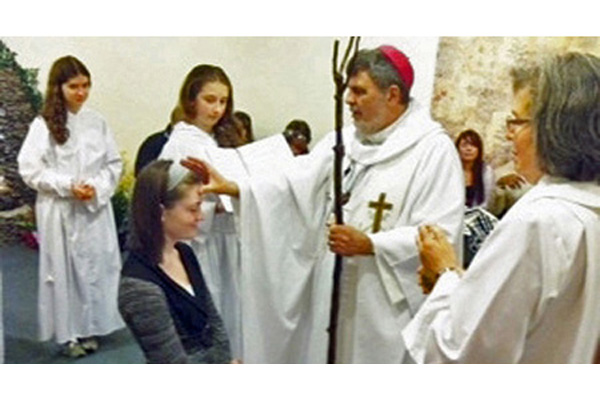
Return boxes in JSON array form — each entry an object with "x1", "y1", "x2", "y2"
[{"x1": 417, "y1": 225, "x2": 462, "y2": 294}]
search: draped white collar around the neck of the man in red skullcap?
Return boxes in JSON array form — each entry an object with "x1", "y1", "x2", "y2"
[{"x1": 346, "y1": 99, "x2": 443, "y2": 165}]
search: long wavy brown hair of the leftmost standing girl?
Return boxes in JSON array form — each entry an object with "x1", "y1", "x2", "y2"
[{"x1": 42, "y1": 56, "x2": 92, "y2": 144}]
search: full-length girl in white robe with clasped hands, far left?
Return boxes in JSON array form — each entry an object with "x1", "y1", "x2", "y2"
[{"x1": 17, "y1": 56, "x2": 124, "y2": 357}]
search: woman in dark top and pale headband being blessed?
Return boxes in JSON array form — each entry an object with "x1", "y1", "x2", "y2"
[{"x1": 119, "y1": 160, "x2": 231, "y2": 363}]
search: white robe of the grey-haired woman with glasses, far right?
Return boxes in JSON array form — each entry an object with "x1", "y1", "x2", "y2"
[{"x1": 403, "y1": 177, "x2": 600, "y2": 363}]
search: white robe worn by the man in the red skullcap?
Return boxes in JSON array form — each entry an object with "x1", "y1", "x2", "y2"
[{"x1": 234, "y1": 103, "x2": 464, "y2": 363}]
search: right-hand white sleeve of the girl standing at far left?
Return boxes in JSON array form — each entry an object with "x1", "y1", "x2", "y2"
[{"x1": 84, "y1": 121, "x2": 123, "y2": 212}]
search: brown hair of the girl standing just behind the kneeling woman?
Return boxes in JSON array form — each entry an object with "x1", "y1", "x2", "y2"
[{"x1": 179, "y1": 64, "x2": 237, "y2": 147}]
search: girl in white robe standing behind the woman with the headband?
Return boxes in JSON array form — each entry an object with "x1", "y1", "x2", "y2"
[{"x1": 159, "y1": 65, "x2": 243, "y2": 358}]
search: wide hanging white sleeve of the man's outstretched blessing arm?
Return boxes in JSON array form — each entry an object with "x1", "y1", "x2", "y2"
[{"x1": 233, "y1": 141, "x2": 330, "y2": 363}]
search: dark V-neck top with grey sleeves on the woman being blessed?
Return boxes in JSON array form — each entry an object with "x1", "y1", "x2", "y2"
[{"x1": 119, "y1": 243, "x2": 231, "y2": 363}]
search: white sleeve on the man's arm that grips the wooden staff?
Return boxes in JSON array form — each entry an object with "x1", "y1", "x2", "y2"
[{"x1": 369, "y1": 135, "x2": 464, "y2": 315}]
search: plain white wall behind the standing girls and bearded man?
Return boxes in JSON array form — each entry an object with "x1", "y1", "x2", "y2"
[{"x1": 1, "y1": 37, "x2": 438, "y2": 165}]
